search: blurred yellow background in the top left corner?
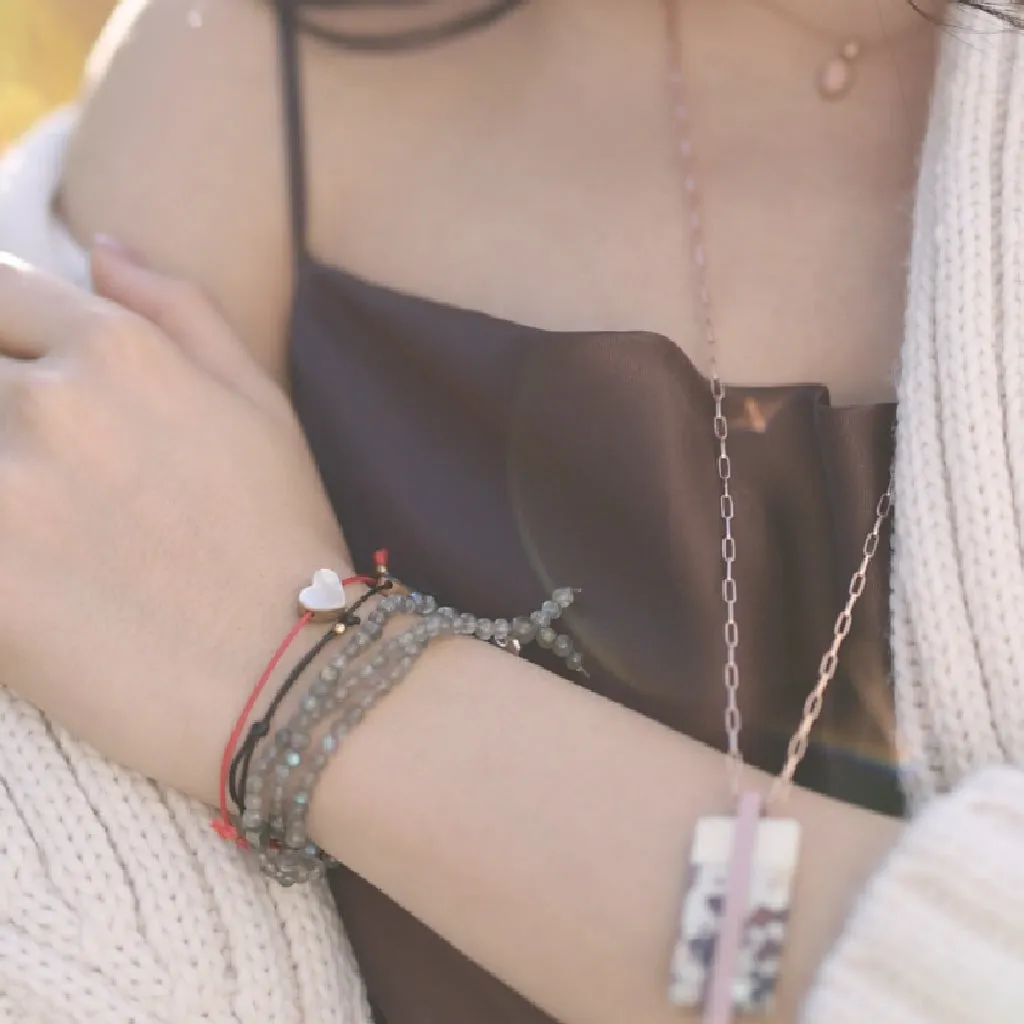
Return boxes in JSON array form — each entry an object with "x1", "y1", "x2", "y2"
[{"x1": 0, "y1": 0, "x2": 116, "y2": 148}]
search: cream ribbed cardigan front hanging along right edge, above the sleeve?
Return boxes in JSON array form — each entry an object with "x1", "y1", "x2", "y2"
[{"x1": 892, "y1": 6, "x2": 1024, "y2": 805}]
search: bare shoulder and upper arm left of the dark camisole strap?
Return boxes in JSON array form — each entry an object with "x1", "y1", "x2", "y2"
[{"x1": 61, "y1": 0, "x2": 299, "y2": 370}]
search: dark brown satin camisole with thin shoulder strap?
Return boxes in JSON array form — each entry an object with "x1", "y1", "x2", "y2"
[{"x1": 281, "y1": 8, "x2": 901, "y2": 1024}]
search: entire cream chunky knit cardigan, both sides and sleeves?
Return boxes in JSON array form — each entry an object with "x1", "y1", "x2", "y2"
[{"x1": 6, "y1": 6, "x2": 1024, "y2": 1024}]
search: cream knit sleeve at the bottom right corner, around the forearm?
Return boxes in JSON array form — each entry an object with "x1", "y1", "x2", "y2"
[{"x1": 801, "y1": 768, "x2": 1024, "y2": 1024}]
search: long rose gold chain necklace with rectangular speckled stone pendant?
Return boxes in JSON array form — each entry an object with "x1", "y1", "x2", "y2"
[{"x1": 663, "y1": 0, "x2": 893, "y2": 1024}]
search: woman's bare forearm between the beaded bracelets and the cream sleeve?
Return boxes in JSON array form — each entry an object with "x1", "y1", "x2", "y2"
[{"x1": 310, "y1": 640, "x2": 899, "y2": 1024}]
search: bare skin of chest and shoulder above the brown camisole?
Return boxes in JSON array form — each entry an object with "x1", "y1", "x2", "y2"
[{"x1": 65, "y1": 0, "x2": 933, "y2": 402}]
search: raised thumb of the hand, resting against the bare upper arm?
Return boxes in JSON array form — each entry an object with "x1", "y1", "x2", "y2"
[{"x1": 91, "y1": 236, "x2": 280, "y2": 409}]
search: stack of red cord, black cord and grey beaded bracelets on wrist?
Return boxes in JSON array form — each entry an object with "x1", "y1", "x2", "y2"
[{"x1": 213, "y1": 551, "x2": 584, "y2": 886}]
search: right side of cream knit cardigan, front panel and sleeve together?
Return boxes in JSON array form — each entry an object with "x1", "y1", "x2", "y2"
[{"x1": 801, "y1": 12, "x2": 1024, "y2": 1024}]
